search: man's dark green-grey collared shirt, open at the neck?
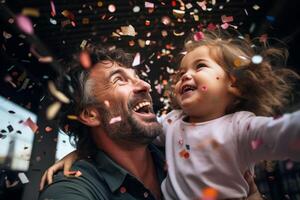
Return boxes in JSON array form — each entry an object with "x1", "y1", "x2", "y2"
[{"x1": 39, "y1": 145, "x2": 166, "y2": 200}]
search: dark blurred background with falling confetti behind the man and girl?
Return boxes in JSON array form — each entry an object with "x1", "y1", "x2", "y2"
[{"x1": 0, "y1": 0, "x2": 300, "y2": 200}]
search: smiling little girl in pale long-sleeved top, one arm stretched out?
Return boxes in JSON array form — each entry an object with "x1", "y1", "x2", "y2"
[{"x1": 40, "y1": 29, "x2": 300, "y2": 200}]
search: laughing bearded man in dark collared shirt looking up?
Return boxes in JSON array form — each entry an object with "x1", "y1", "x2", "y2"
[{"x1": 39, "y1": 46, "x2": 255, "y2": 200}]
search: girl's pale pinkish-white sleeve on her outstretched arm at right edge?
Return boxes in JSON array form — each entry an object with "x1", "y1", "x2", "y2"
[{"x1": 234, "y1": 111, "x2": 300, "y2": 165}]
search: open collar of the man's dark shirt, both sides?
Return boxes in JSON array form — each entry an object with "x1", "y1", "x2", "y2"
[{"x1": 95, "y1": 144, "x2": 165, "y2": 192}]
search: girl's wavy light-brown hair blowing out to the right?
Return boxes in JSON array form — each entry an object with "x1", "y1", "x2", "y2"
[{"x1": 173, "y1": 28, "x2": 299, "y2": 116}]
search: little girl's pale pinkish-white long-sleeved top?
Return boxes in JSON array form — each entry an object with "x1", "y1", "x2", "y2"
[{"x1": 155, "y1": 110, "x2": 300, "y2": 200}]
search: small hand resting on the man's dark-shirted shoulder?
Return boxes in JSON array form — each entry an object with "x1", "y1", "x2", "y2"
[{"x1": 40, "y1": 150, "x2": 78, "y2": 190}]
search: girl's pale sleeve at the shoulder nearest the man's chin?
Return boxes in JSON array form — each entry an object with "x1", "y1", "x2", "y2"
[{"x1": 153, "y1": 110, "x2": 182, "y2": 147}]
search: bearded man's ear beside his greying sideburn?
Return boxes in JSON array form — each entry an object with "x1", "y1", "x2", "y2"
[{"x1": 78, "y1": 108, "x2": 101, "y2": 126}]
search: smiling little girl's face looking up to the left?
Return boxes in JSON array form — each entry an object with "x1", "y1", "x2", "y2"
[{"x1": 175, "y1": 46, "x2": 238, "y2": 122}]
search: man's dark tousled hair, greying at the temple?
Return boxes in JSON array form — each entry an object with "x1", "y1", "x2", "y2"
[{"x1": 57, "y1": 44, "x2": 133, "y2": 157}]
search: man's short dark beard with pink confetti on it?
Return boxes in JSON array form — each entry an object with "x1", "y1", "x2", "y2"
[{"x1": 98, "y1": 99, "x2": 162, "y2": 145}]
